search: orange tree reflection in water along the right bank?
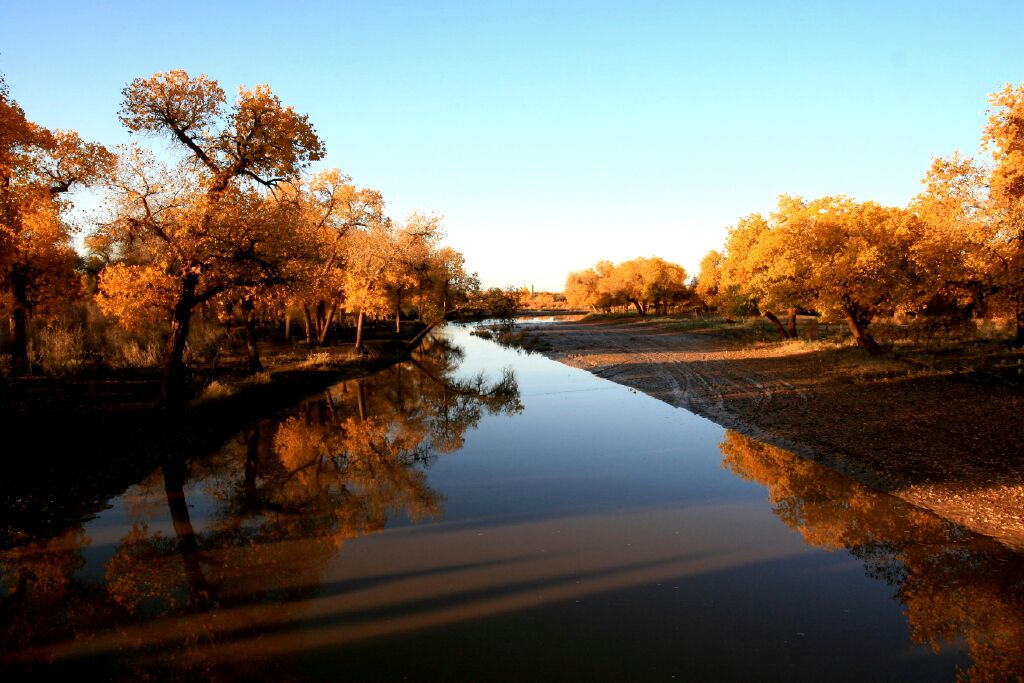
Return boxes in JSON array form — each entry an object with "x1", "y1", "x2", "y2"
[{"x1": 720, "y1": 430, "x2": 1024, "y2": 681}]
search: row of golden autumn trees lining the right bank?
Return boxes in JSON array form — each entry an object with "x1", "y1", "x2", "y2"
[{"x1": 565, "y1": 84, "x2": 1024, "y2": 353}]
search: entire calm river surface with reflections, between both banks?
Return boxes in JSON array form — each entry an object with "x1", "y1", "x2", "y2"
[{"x1": 0, "y1": 327, "x2": 1024, "y2": 681}]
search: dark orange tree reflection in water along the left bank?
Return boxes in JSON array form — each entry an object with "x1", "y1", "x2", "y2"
[{"x1": 0, "y1": 339, "x2": 522, "y2": 679}]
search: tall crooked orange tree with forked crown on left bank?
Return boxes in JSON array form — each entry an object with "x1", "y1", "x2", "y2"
[{"x1": 100, "y1": 71, "x2": 324, "y2": 402}]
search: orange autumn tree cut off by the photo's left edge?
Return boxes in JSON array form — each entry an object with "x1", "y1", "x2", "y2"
[{"x1": 0, "y1": 78, "x2": 113, "y2": 375}]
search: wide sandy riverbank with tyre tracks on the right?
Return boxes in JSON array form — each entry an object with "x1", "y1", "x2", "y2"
[{"x1": 529, "y1": 319, "x2": 1024, "y2": 550}]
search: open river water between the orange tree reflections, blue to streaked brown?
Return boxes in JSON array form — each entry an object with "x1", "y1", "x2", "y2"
[{"x1": 37, "y1": 321, "x2": 964, "y2": 680}]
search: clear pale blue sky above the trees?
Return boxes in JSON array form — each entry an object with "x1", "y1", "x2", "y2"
[{"x1": 0, "y1": 0, "x2": 1024, "y2": 291}]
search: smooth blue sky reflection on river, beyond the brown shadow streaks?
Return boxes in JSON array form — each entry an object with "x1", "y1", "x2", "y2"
[{"x1": 430, "y1": 325, "x2": 763, "y2": 519}]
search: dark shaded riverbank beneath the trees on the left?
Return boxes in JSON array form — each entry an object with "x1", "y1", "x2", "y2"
[{"x1": 0, "y1": 328, "x2": 420, "y2": 548}]
